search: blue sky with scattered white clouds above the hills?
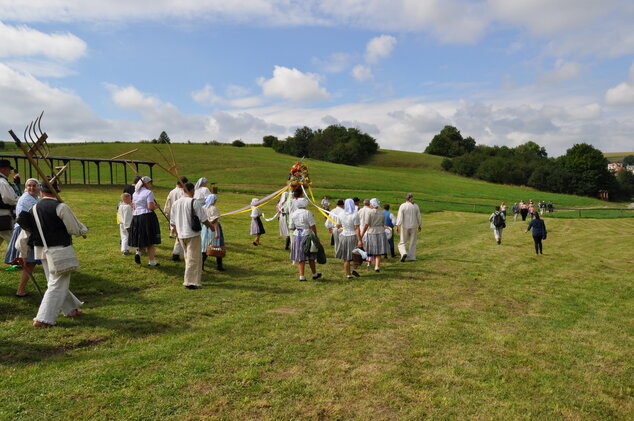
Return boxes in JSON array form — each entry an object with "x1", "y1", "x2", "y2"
[{"x1": 0, "y1": 0, "x2": 634, "y2": 156}]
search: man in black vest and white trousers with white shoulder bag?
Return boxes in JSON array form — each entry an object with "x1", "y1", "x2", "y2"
[{"x1": 30, "y1": 183, "x2": 88, "y2": 327}]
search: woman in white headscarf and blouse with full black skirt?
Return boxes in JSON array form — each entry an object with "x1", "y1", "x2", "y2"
[{"x1": 128, "y1": 176, "x2": 161, "y2": 267}]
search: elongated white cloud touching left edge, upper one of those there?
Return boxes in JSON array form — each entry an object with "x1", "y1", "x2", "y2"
[{"x1": 0, "y1": 21, "x2": 86, "y2": 61}]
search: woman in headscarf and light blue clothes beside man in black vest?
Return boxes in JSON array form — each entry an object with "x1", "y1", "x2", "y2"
[{"x1": 4, "y1": 178, "x2": 42, "y2": 297}]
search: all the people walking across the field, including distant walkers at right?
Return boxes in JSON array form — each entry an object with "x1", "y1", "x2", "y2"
[{"x1": 0, "y1": 160, "x2": 552, "y2": 327}]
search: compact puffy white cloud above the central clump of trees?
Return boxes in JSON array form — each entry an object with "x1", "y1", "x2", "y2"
[{"x1": 258, "y1": 66, "x2": 330, "y2": 102}]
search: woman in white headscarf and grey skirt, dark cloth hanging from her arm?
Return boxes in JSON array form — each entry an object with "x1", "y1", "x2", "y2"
[{"x1": 289, "y1": 197, "x2": 321, "y2": 281}]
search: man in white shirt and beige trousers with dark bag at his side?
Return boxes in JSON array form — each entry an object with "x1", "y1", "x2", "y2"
[{"x1": 170, "y1": 183, "x2": 211, "y2": 289}]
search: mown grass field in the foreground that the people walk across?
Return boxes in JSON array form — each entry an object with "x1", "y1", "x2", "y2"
[{"x1": 0, "y1": 187, "x2": 634, "y2": 420}]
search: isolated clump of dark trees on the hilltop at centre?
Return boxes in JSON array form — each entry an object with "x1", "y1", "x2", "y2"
[{"x1": 262, "y1": 124, "x2": 379, "y2": 165}]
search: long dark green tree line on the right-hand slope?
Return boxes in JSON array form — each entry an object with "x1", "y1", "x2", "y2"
[{"x1": 425, "y1": 126, "x2": 634, "y2": 201}]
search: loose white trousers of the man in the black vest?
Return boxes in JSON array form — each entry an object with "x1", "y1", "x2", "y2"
[{"x1": 33, "y1": 259, "x2": 84, "y2": 325}]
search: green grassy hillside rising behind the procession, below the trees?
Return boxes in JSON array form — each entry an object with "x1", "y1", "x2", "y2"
[{"x1": 1, "y1": 143, "x2": 624, "y2": 212}]
